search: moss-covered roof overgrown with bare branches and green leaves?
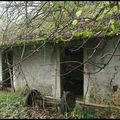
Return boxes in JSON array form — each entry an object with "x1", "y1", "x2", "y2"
[{"x1": 0, "y1": 1, "x2": 120, "y2": 43}]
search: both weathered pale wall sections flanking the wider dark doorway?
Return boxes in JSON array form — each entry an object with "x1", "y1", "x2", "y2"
[{"x1": 13, "y1": 38, "x2": 120, "y2": 103}]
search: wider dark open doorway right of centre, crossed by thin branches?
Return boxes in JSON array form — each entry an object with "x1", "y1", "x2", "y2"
[{"x1": 61, "y1": 47, "x2": 84, "y2": 100}]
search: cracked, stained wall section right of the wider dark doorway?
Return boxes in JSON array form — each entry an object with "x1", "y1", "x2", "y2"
[{"x1": 84, "y1": 38, "x2": 120, "y2": 103}]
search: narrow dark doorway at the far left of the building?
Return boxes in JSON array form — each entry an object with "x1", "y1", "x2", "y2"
[{"x1": 2, "y1": 49, "x2": 13, "y2": 88}]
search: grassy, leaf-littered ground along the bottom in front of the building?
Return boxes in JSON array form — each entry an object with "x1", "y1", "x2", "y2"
[{"x1": 0, "y1": 91, "x2": 120, "y2": 119}]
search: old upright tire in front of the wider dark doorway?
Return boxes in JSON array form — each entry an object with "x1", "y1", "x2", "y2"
[{"x1": 60, "y1": 91, "x2": 76, "y2": 115}]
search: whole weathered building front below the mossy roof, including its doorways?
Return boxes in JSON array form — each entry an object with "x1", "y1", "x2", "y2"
[{"x1": 0, "y1": 34, "x2": 120, "y2": 102}]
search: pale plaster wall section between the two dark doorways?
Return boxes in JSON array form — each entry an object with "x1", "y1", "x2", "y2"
[{"x1": 13, "y1": 44, "x2": 60, "y2": 97}]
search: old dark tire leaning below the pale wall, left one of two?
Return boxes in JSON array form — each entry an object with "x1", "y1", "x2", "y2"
[{"x1": 25, "y1": 89, "x2": 41, "y2": 107}]
